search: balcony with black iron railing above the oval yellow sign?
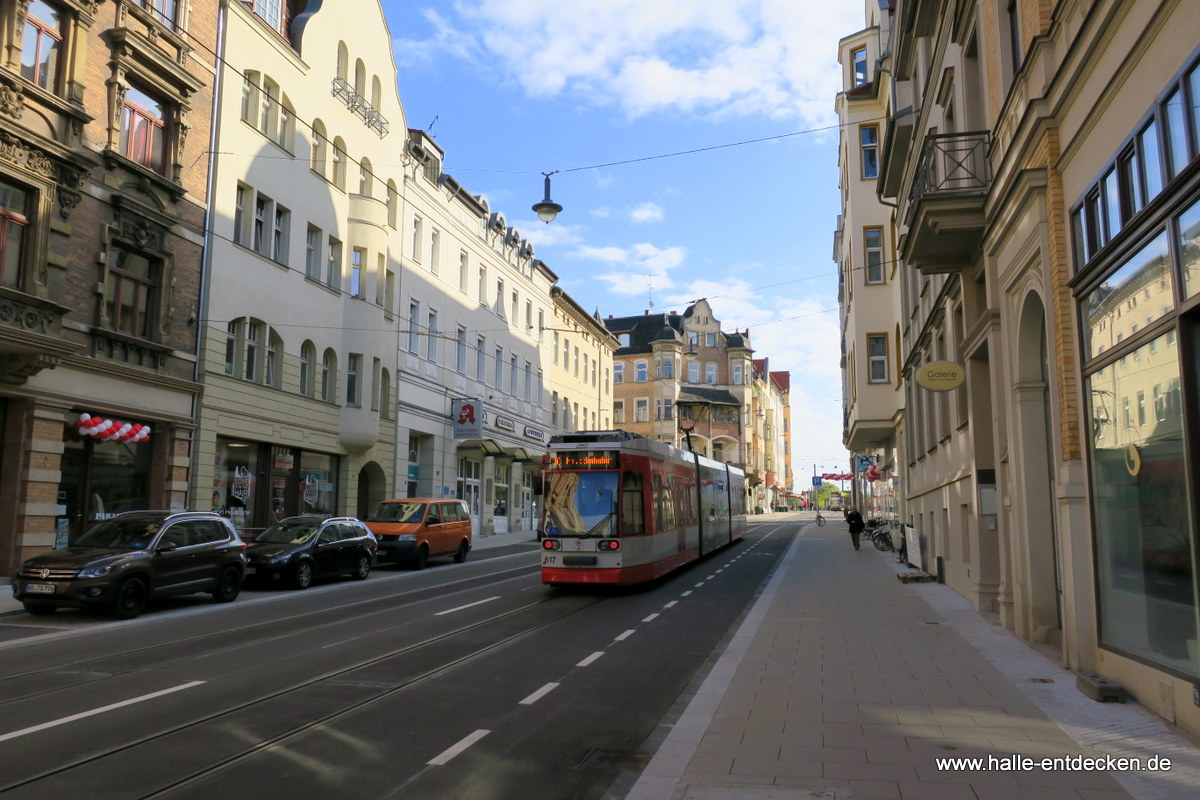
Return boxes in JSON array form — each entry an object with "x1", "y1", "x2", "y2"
[{"x1": 900, "y1": 131, "x2": 991, "y2": 273}]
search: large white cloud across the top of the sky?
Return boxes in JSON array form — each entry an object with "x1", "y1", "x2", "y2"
[{"x1": 397, "y1": 0, "x2": 863, "y2": 125}]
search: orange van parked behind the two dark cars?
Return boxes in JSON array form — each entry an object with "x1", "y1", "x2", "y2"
[{"x1": 367, "y1": 498, "x2": 470, "y2": 570}]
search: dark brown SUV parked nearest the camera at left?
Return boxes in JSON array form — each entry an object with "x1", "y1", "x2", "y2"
[{"x1": 12, "y1": 511, "x2": 246, "y2": 619}]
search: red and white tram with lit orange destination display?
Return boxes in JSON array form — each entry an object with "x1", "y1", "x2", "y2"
[{"x1": 539, "y1": 431, "x2": 746, "y2": 585}]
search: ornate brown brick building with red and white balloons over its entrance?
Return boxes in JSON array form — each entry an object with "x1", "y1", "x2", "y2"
[{"x1": 0, "y1": 0, "x2": 217, "y2": 570}]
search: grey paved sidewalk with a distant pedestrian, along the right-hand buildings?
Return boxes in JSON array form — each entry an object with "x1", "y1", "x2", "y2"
[{"x1": 626, "y1": 515, "x2": 1200, "y2": 800}]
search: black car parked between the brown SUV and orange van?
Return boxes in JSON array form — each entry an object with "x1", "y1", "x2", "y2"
[{"x1": 246, "y1": 517, "x2": 376, "y2": 589}]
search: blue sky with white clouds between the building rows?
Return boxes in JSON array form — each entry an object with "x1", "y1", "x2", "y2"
[{"x1": 383, "y1": 0, "x2": 864, "y2": 489}]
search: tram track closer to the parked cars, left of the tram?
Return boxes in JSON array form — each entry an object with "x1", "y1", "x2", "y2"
[{"x1": 0, "y1": 566, "x2": 536, "y2": 711}]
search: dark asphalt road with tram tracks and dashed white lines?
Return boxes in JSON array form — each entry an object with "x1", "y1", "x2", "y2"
[{"x1": 0, "y1": 523, "x2": 797, "y2": 800}]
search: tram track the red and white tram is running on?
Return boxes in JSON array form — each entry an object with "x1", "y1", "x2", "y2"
[{"x1": 0, "y1": 575, "x2": 606, "y2": 800}]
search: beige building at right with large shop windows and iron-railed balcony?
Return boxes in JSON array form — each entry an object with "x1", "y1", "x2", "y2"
[{"x1": 847, "y1": 0, "x2": 1200, "y2": 734}]
